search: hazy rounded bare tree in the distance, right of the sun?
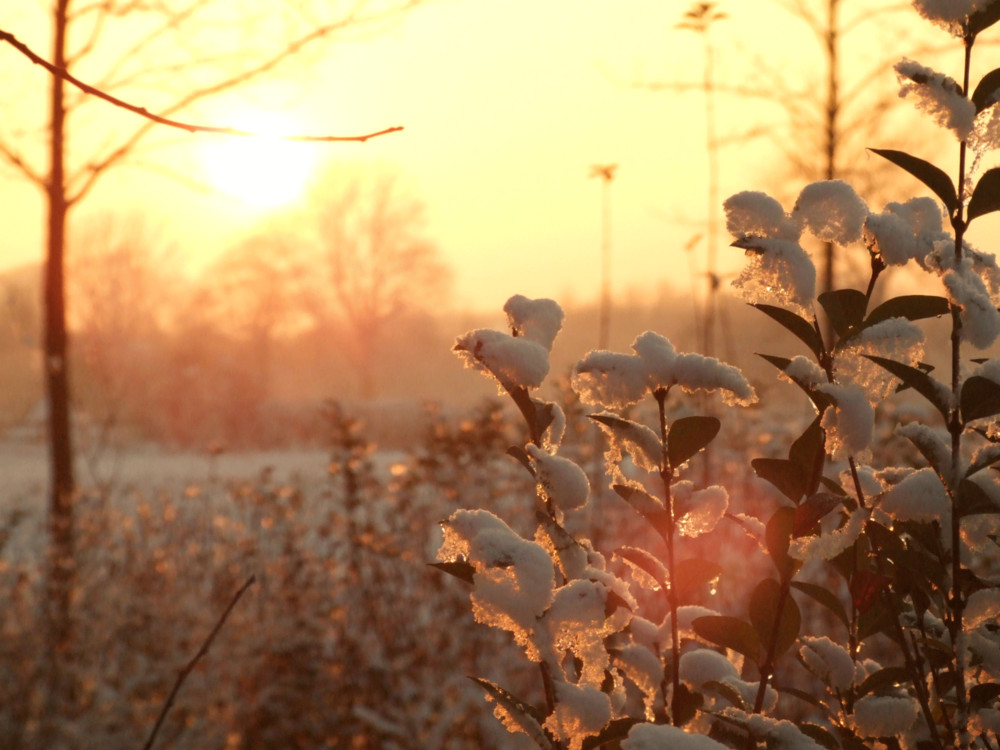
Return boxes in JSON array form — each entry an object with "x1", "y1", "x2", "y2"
[{"x1": 317, "y1": 173, "x2": 450, "y2": 399}]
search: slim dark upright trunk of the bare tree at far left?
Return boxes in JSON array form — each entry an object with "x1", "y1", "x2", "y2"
[{"x1": 43, "y1": 0, "x2": 75, "y2": 744}]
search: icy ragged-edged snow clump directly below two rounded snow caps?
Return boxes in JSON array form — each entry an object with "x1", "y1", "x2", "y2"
[{"x1": 733, "y1": 237, "x2": 816, "y2": 313}]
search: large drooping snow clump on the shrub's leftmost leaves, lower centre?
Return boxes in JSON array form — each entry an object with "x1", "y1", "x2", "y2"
[{"x1": 438, "y1": 510, "x2": 555, "y2": 661}]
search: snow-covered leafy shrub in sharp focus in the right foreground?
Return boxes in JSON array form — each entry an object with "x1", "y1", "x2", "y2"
[{"x1": 438, "y1": 0, "x2": 1000, "y2": 750}]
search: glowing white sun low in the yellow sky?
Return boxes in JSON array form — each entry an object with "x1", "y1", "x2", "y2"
[{"x1": 203, "y1": 112, "x2": 315, "y2": 208}]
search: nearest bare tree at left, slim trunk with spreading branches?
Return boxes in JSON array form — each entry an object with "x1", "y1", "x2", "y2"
[{"x1": 0, "y1": 0, "x2": 418, "y2": 740}]
